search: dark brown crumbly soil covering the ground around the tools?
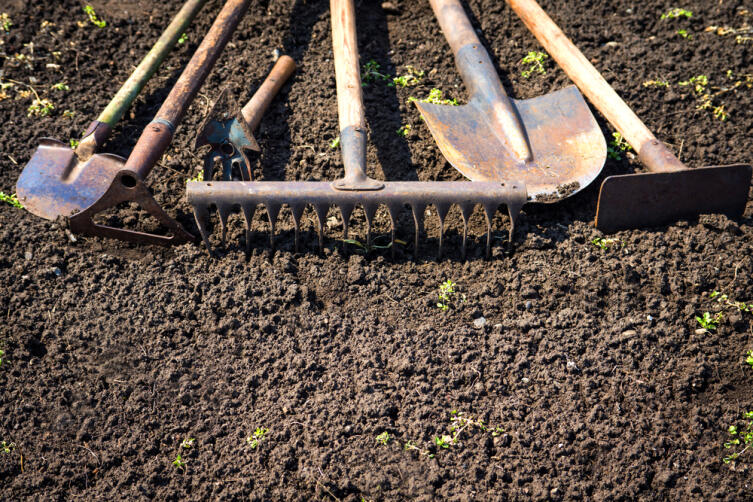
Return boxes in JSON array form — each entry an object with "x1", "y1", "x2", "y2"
[{"x1": 0, "y1": 0, "x2": 753, "y2": 501}]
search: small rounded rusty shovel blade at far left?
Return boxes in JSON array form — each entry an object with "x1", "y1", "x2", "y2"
[{"x1": 16, "y1": 138, "x2": 125, "y2": 220}]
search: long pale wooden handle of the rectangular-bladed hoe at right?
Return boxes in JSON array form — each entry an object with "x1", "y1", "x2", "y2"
[{"x1": 506, "y1": 0, "x2": 686, "y2": 171}]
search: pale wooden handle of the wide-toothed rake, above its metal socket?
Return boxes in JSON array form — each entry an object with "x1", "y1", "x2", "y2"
[{"x1": 330, "y1": 0, "x2": 366, "y2": 131}]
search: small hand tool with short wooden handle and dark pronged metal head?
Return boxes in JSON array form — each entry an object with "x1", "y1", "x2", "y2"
[{"x1": 194, "y1": 56, "x2": 295, "y2": 181}]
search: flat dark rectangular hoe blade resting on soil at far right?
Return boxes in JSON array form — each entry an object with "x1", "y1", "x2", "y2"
[{"x1": 596, "y1": 164, "x2": 751, "y2": 233}]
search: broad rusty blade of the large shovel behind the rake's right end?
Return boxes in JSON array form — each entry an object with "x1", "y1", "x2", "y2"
[{"x1": 416, "y1": 86, "x2": 607, "y2": 202}]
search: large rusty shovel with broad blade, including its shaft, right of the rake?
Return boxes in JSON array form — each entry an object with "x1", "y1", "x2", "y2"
[{"x1": 416, "y1": 0, "x2": 607, "y2": 202}]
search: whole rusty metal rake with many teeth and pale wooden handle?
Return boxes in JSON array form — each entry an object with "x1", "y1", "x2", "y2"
[{"x1": 187, "y1": 0, "x2": 526, "y2": 256}]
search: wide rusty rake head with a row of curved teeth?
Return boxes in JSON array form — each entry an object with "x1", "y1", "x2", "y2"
[{"x1": 187, "y1": 181, "x2": 527, "y2": 257}]
